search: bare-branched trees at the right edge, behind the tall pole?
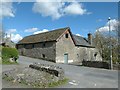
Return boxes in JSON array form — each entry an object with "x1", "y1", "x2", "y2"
[{"x1": 93, "y1": 30, "x2": 120, "y2": 63}]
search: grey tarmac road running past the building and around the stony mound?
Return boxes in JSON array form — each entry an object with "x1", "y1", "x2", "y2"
[{"x1": 2, "y1": 56, "x2": 118, "y2": 88}]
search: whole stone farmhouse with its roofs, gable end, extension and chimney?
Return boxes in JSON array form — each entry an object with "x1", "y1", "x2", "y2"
[{"x1": 16, "y1": 27, "x2": 102, "y2": 63}]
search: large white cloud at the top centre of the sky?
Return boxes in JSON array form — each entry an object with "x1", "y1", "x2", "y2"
[{"x1": 32, "y1": 0, "x2": 91, "y2": 19}]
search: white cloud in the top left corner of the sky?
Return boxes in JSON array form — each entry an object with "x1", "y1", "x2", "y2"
[{"x1": 0, "y1": 0, "x2": 15, "y2": 18}]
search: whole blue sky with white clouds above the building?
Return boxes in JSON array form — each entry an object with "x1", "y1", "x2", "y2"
[{"x1": 0, "y1": 0, "x2": 118, "y2": 42}]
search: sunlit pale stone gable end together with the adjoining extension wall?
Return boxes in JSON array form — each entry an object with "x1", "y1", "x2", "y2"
[{"x1": 56, "y1": 29, "x2": 102, "y2": 64}]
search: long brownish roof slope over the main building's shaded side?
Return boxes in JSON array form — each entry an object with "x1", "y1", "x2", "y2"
[{"x1": 18, "y1": 27, "x2": 69, "y2": 44}]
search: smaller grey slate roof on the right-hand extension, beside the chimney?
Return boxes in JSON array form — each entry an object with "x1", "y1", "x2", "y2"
[{"x1": 72, "y1": 35, "x2": 93, "y2": 47}]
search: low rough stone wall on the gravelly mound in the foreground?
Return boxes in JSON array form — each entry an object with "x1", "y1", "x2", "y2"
[{"x1": 29, "y1": 63, "x2": 64, "y2": 80}]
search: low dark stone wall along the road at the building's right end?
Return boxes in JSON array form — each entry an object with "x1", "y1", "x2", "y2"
[{"x1": 82, "y1": 61, "x2": 109, "y2": 69}]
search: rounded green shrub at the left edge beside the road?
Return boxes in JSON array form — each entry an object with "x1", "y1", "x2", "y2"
[{"x1": 2, "y1": 47, "x2": 18, "y2": 60}]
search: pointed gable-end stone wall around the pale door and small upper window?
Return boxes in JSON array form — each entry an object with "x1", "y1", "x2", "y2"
[{"x1": 56, "y1": 31, "x2": 75, "y2": 63}]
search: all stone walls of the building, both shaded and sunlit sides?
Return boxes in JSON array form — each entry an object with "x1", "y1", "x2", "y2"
[{"x1": 18, "y1": 31, "x2": 102, "y2": 64}]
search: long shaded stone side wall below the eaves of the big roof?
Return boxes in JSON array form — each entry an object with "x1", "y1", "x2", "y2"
[{"x1": 18, "y1": 42, "x2": 56, "y2": 62}]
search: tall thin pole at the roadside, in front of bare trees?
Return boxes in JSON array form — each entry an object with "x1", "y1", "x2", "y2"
[{"x1": 108, "y1": 17, "x2": 113, "y2": 69}]
